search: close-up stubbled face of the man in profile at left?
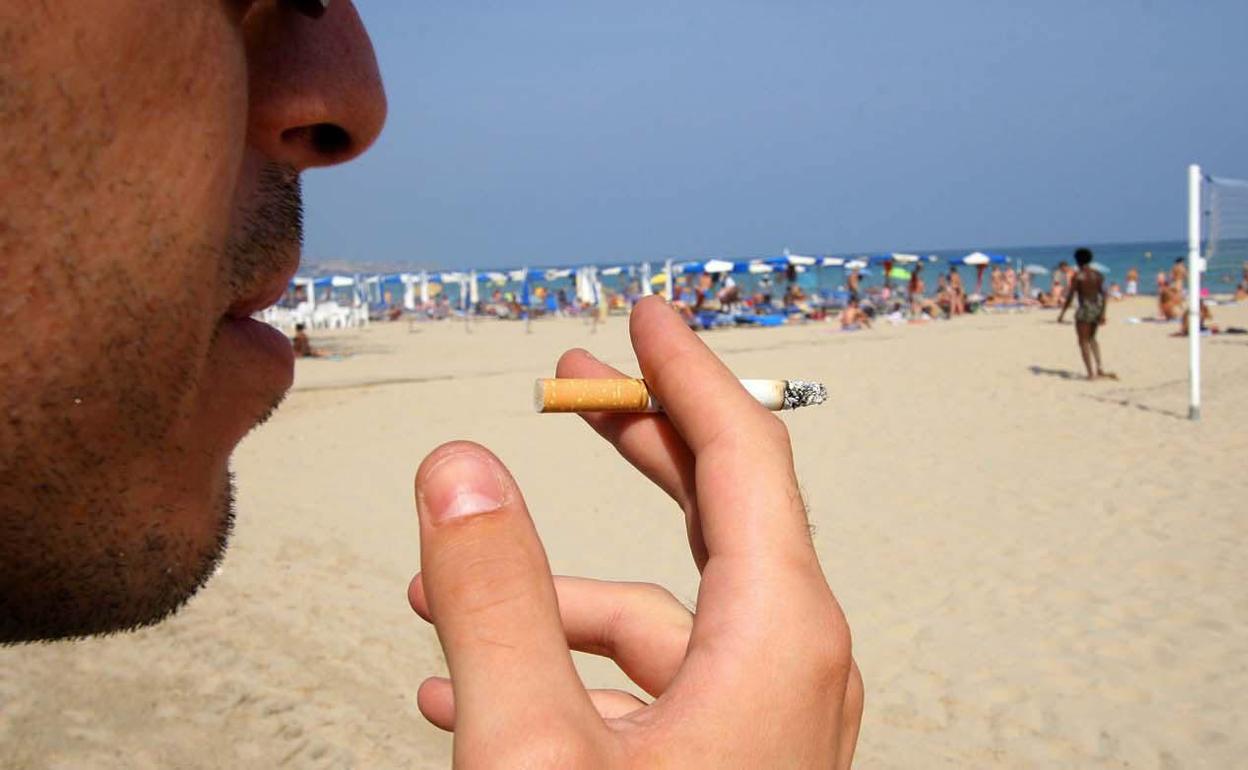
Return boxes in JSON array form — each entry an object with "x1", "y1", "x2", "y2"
[{"x1": 0, "y1": 0, "x2": 386, "y2": 643}]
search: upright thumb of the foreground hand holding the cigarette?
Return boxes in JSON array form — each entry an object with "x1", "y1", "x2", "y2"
[{"x1": 416, "y1": 443, "x2": 594, "y2": 740}]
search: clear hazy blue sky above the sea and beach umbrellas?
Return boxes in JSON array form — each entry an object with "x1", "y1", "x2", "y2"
[{"x1": 306, "y1": 0, "x2": 1248, "y2": 267}]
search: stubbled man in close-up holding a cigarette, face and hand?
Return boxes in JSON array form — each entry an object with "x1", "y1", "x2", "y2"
[{"x1": 0, "y1": 0, "x2": 862, "y2": 770}]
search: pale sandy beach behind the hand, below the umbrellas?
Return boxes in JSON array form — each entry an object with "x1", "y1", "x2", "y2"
[{"x1": 0, "y1": 300, "x2": 1248, "y2": 770}]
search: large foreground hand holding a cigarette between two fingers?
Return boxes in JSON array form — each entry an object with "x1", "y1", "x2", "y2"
[{"x1": 409, "y1": 300, "x2": 862, "y2": 769}]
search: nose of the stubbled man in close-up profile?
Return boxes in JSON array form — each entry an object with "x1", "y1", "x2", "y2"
[{"x1": 243, "y1": 0, "x2": 386, "y2": 171}]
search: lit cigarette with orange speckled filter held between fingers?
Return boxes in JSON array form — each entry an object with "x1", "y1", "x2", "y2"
[{"x1": 533, "y1": 378, "x2": 827, "y2": 414}]
